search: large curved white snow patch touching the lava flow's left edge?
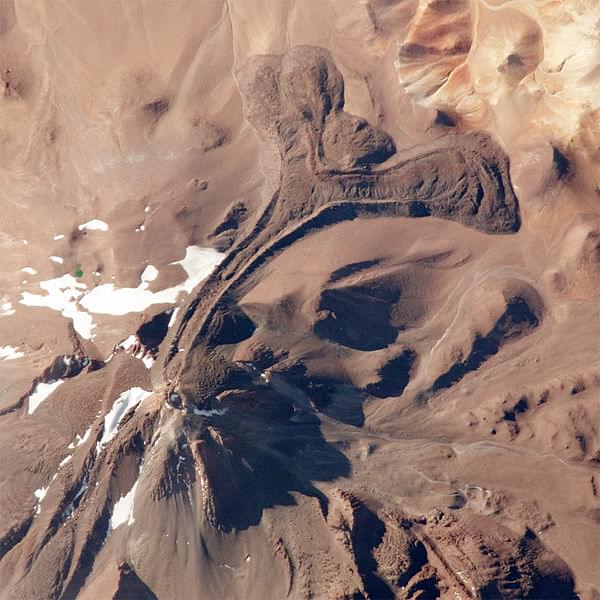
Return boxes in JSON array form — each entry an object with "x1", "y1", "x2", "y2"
[{"x1": 80, "y1": 246, "x2": 224, "y2": 315}]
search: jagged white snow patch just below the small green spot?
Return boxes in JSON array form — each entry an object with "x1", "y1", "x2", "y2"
[{"x1": 20, "y1": 274, "x2": 95, "y2": 340}]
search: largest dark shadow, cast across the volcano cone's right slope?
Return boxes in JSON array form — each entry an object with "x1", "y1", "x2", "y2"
[{"x1": 171, "y1": 385, "x2": 350, "y2": 531}]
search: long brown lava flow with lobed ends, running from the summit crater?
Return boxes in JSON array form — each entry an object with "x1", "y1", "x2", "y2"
[{"x1": 165, "y1": 46, "x2": 520, "y2": 395}]
